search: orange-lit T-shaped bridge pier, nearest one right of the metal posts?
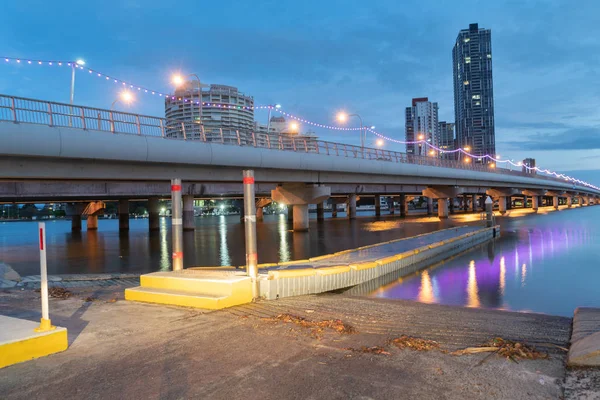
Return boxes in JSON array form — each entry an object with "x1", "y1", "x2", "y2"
[{"x1": 271, "y1": 184, "x2": 331, "y2": 231}]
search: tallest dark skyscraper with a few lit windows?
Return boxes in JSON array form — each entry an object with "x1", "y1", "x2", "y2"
[{"x1": 452, "y1": 24, "x2": 496, "y2": 163}]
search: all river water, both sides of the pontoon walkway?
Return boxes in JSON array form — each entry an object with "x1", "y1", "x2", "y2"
[{"x1": 0, "y1": 207, "x2": 600, "y2": 316}]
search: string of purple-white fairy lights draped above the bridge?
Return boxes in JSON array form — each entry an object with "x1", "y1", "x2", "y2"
[{"x1": 0, "y1": 57, "x2": 600, "y2": 190}]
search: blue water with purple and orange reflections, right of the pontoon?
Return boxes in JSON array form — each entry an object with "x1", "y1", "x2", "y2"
[{"x1": 373, "y1": 208, "x2": 600, "y2": 316}]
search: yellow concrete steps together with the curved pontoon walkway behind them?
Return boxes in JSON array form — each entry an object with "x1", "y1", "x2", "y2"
[{"x1": 125, "y1": 226, "x2": 500, "y2": 309}]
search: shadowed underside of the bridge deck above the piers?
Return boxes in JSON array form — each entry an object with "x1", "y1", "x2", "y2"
[{"x1": 0, "y1": 157, "x2": 576, "y2": 202}]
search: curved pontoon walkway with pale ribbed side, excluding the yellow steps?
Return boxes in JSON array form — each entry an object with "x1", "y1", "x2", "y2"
[{"x1": 260, "y1": 226, "x2": 500, "y2": 300}]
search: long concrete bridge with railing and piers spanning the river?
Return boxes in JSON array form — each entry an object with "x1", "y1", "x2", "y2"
[{"x1": 0, "y1": 95, "x2": 600, "y2": 231}]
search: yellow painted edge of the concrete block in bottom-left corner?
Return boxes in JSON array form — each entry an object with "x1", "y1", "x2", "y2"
[{"x1": 0, "y1": 328, "x2": 69, "y2": 368}]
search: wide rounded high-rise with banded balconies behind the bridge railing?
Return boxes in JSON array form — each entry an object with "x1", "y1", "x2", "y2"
[{"x1": 165, "y1": 81, "x2": 254, "y2": 143}]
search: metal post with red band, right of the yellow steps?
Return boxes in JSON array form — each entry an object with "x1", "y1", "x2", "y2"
[{"x1": 242, "y1": 170, "x2": 260, "y2": 300}]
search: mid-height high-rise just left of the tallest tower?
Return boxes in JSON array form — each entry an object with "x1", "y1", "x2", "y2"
[{"x1": 405, "y1": 97, "x2": 439, "y2": 155}]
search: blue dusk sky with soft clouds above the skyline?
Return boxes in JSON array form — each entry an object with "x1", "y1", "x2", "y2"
[{"x1": 0, "y1": 0, "x2": 600, "y2": 184}]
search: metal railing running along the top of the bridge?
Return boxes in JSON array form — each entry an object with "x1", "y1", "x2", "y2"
[{"x1": 0, "y1": 95, "x2": 576, "y2": 188}]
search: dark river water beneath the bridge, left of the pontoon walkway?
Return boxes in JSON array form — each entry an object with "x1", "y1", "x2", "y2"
[{"x1": 0, "y1": 214, "x2": 457, "y2": 275}]
